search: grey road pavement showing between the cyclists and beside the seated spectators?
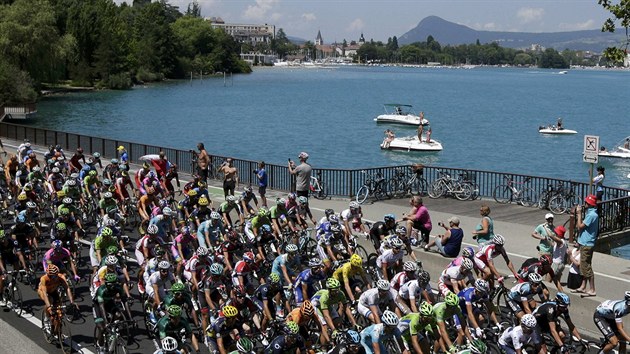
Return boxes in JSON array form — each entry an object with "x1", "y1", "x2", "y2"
[{"x1": 0, "y1": 139, "x2": 630, "y2": 352}]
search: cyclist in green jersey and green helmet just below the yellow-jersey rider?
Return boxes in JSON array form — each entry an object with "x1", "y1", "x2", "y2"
[{"x1": 311, "y1": 278, "x2": 357, "y2": 345}]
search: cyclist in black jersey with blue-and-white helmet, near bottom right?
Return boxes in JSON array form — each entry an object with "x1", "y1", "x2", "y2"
[{"x1": 532, "y1": 292, "x2": 582, "y2": 353}]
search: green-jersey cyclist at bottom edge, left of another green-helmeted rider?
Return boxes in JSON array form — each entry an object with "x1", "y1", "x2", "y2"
[{"x1": 398, "y1": 301, "x2": 439, "y2": 354}]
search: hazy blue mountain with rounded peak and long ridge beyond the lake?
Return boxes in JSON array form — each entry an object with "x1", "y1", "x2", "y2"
[{"x1": 398, "y1": 16, "x2": 623, "y2": 52}]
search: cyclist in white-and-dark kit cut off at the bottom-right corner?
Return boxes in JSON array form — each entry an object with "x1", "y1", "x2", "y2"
[{"x1": 593, "y1": 291, "x2": 630, "y2": 353}]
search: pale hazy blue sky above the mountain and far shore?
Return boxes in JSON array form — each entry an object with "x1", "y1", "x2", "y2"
[{"x1": 126, "y1": 0, "x2": 609, "y2": 43}]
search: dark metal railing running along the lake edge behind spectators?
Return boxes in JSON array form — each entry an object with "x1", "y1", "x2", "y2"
[{"x1": 0, "y1": 122, "x2": 630, "y2": 235}]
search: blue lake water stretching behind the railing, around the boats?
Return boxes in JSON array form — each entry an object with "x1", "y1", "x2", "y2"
[{"x1": 32, "y1": 67, "x2": 630, "y2": 188}]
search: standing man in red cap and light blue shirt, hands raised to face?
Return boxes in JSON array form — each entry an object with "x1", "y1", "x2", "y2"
[{"x1": 572, "y1": 194, "x2": 599, "y2": 296}]
